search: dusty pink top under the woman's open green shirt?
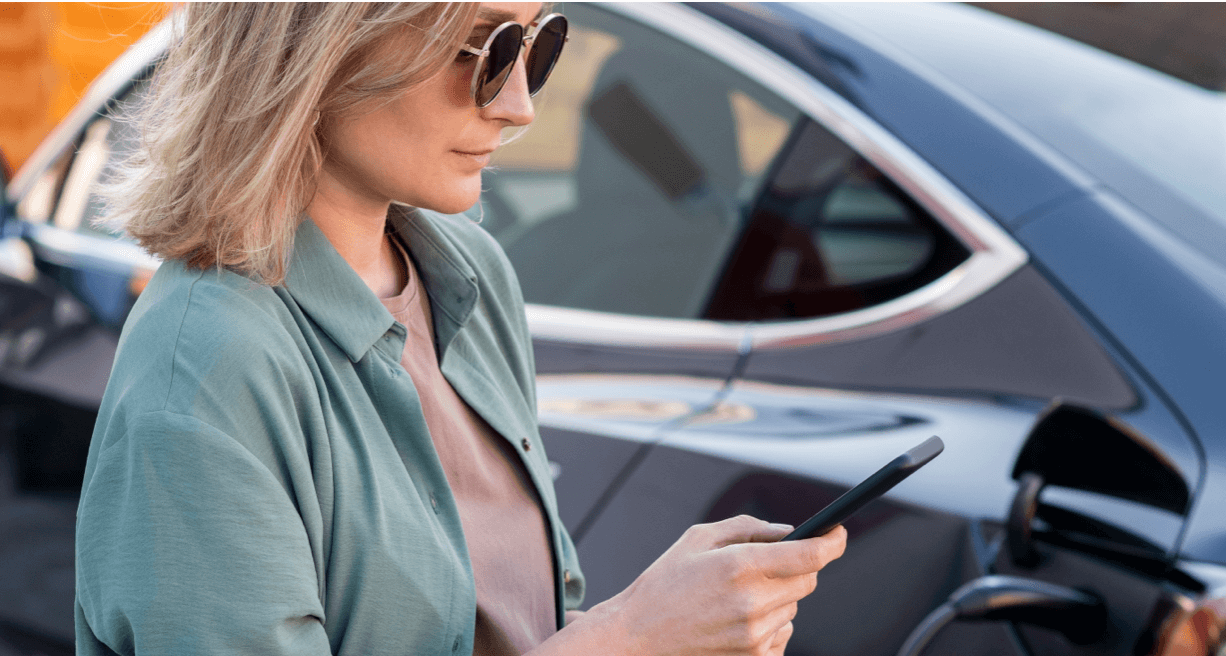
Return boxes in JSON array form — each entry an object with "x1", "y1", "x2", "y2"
[{"x1": 380, "y1": 239, "x2": 557, "y2": 656}]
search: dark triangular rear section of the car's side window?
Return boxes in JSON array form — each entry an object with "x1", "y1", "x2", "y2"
[{"x1": 706, "y1": 120, "x2": 970, "y2": 321}]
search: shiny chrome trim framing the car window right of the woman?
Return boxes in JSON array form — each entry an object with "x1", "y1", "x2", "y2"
[{"x1": 527, "y1": 2, "x2": 1027, "y2": 351}]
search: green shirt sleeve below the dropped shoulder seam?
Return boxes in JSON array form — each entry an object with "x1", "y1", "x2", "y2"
[{"x1": 77, "y1": 412, "x2": 331, "y2": 656}]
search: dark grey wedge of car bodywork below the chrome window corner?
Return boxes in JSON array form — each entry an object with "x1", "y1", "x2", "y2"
[{"x1": 743, "y1": 267, "x2": 1137, "y2": 408}]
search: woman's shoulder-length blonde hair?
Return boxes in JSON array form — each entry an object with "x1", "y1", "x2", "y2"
[{"x1": 103, "y1": 2, "x2": 478, "y2": 284}]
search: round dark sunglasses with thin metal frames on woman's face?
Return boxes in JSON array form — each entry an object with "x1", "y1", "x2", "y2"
[{"x1": 460, "y1": 13, "x2": 569, "y2": 107}]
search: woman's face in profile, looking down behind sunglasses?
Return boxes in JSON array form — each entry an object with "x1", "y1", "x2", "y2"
[{"x1": 320, "y1": 2, "x2": 541, "y2": 213}]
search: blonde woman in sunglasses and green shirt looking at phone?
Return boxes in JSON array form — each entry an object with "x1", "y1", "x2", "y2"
[{"x1": 76, "y1": 4, "x2": 845, "y2": 655}]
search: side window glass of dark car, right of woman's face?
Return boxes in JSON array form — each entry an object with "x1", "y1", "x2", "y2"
[{"x1": 483, "y1": 5, "x2": 969, "y2": 320}]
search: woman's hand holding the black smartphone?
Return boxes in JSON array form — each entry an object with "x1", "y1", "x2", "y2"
[{"x1": 576, "y1": 515, "x2": 847, "y2": 656}]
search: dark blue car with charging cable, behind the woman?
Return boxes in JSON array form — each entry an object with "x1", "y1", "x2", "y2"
[{"x1": 0, "y1": 4, "x2": 1226, "y2": 656}]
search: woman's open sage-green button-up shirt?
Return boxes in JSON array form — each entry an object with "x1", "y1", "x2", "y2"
[{"x1": 76, "y1": 206, "x2": 584, "y2": 656}]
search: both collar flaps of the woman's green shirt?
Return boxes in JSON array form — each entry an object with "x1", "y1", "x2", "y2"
[{"x1": 284, "y1": 205, "x2": 477, "y2": 362}]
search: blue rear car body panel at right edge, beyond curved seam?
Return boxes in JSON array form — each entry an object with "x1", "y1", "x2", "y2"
[{"x1": 1018, "y1": 191, "x2": 1226, "y2": 563}]
